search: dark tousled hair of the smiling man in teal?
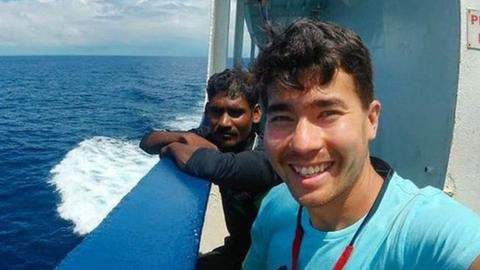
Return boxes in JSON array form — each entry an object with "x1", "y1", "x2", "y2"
[{"x1": 253, "y1": 19, "x2": 373, "y2": 109}]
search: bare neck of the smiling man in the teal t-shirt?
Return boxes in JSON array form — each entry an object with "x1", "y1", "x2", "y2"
[{"x1": 307, "y1": 160, "x2": 383, "y2": 231}]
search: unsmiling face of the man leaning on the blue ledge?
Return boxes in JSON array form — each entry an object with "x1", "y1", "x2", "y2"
[{"x1": 207, "y1": 92, "x2": 261, "y2": 150}]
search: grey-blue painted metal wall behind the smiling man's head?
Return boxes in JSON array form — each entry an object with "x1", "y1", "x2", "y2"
[{"x1": 246, "y1": 0, "x2": 460, "y2": 188}]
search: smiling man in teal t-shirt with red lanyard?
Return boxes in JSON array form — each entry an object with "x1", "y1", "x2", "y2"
[{"x1": 244, "y1": 20, "x2": 480, "y2": 270}]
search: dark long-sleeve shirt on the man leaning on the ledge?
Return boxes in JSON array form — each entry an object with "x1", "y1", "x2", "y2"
[{"x1": 186, "y1": 129, "x2": 281, "y2": 257}]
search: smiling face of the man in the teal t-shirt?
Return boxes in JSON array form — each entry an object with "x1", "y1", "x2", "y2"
[{"x1": 264, "y1": 69, "x2": 380, "y2": 207}]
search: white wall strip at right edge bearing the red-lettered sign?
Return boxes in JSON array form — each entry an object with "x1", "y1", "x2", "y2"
[{"x1": 439, "y1": 0, "x2": 480, "y2": 213}]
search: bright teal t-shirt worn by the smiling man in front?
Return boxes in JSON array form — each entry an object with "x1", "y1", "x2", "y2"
[{"x1": 244, "y1": 173, "x2": 480, "y2": 270}]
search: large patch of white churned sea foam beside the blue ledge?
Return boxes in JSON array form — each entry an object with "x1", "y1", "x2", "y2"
[{"x1": 49, "y1": 137, "x2": 158, "y2": 235}]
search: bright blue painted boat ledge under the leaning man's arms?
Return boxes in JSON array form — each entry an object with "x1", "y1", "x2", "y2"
[{"x1": 57, "y1": 159, "x2": 210, "y2": 270}]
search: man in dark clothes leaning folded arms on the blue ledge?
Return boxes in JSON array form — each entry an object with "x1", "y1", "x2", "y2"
[{"x1": 140, "y1": 69, "x2": 280, "y2": 270}]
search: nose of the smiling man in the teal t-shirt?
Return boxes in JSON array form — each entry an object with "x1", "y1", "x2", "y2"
[{"x1": 289, "y1": 119, "x2": 325, "y2": 154}]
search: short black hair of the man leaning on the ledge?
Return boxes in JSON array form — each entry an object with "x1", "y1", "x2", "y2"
[{"x1": 207, "y1": 69, "x2": 259, "y2": 108}]
